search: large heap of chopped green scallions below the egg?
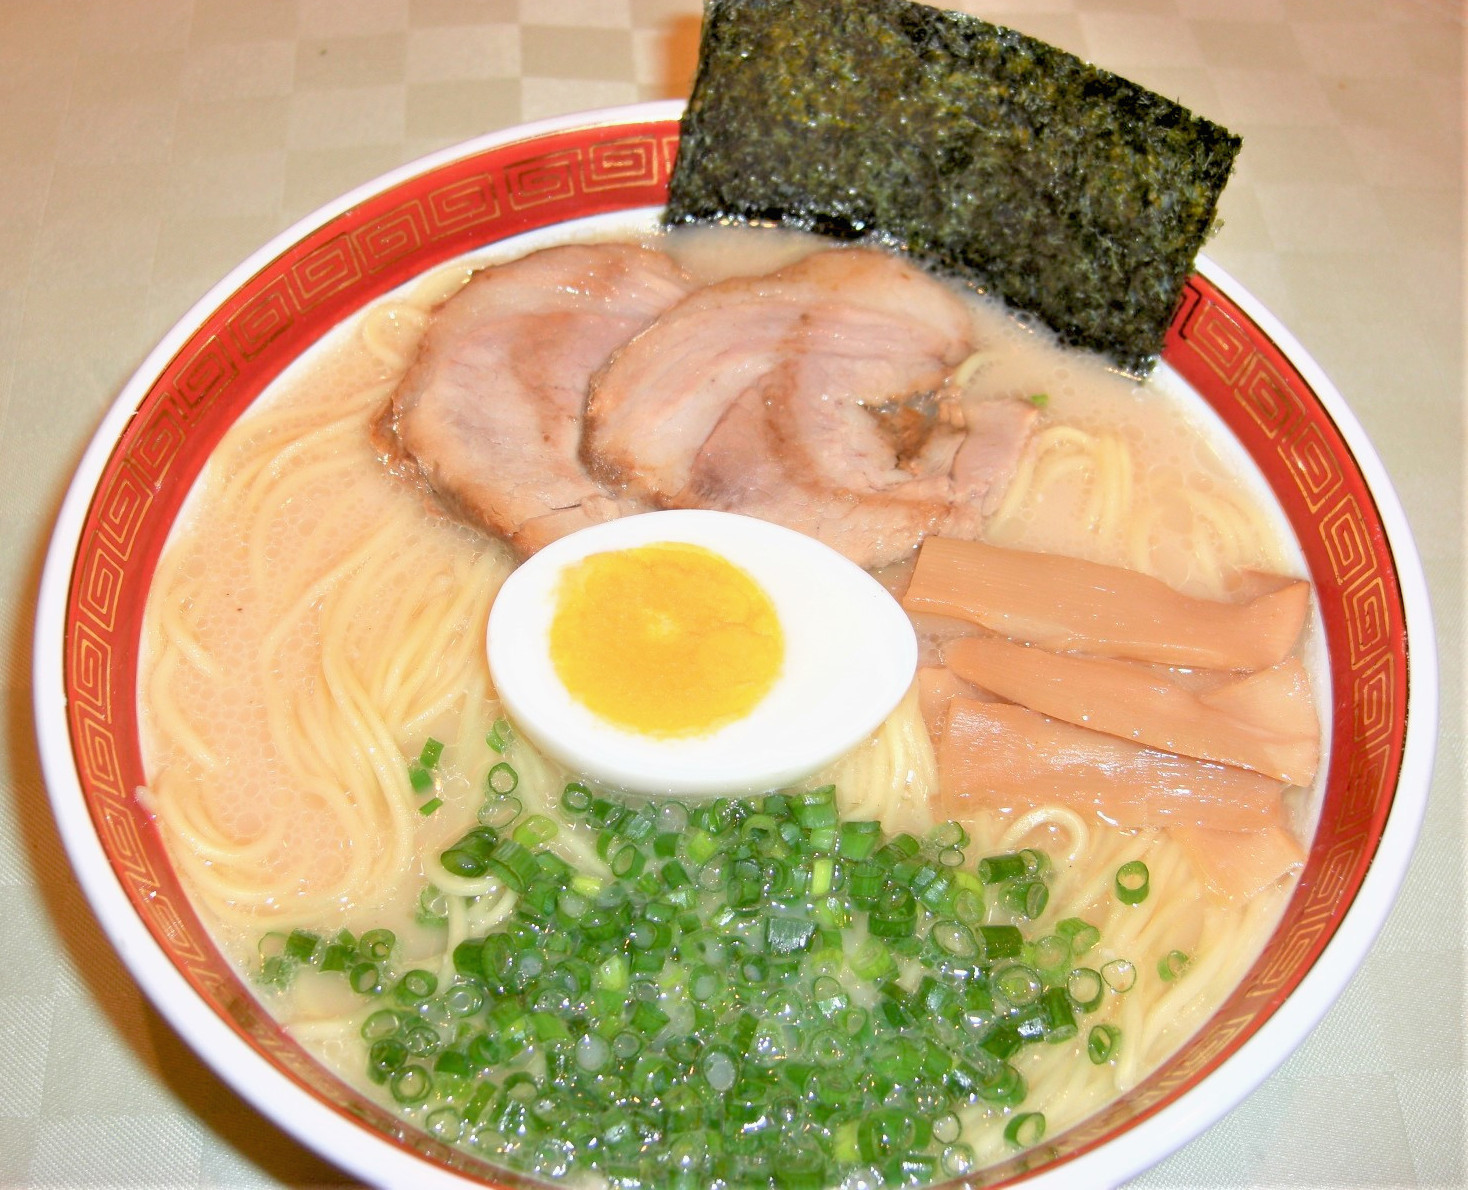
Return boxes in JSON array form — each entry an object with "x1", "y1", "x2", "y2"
[{"x1": 277, "y1": 780, "x2": 1135, "y2": 1190}]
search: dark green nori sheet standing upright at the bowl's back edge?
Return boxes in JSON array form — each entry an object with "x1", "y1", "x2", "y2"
[{"x1": 666, "y1": 0, "x2": 1240, "y2": 374}]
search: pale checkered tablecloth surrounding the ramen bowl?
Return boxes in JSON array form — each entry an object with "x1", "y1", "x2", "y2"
[{"x1": 0, "y1": 0, "x2": 1465, "y2": 1187}]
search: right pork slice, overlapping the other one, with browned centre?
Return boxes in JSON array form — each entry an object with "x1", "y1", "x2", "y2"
[{"x1": 584, "y1": 248, "x2": 1032, "y2": 566}]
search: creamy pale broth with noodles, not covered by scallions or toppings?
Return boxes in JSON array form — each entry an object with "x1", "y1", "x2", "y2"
[{"x1": 139, "y1": 229, "x2": 1318, "y2": 1172}]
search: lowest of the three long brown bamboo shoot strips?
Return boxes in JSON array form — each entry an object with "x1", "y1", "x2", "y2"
[{"x1": 938, "y1": 698, "x2": 1285, "y2": 831}]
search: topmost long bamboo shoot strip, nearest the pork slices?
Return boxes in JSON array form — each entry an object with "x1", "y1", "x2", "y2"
[{"x1": 903, "y1": 537, "x2": 1309, "y2": 671}]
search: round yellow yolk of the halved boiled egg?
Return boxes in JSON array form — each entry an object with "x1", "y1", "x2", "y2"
[{"x1": 551, "y1": 541, "x2": 785, "y2": 738}]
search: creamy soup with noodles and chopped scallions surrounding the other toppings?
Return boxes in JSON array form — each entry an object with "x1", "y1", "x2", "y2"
[{"x1": 139, "y1": 230, "x2": 1321, "y2": 1187}]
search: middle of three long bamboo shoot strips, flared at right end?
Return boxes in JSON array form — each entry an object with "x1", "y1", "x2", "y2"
[{"x1": 942, "y1": 637, "x2": 1320, "y2": 785}]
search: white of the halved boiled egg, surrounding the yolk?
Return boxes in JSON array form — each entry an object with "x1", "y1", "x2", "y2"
[{"x1": 487, "y1": 509, "x2": 918, "y2": 795}]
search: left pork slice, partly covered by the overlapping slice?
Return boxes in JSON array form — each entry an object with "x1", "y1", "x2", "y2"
[{"x1": 386, "y1": 244, "x2": 691, "y2": 553}]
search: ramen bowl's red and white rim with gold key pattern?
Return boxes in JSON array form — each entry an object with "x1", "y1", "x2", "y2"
[{"x1": 34, "y1": 104, "x2": 1437, "y2": 1186}]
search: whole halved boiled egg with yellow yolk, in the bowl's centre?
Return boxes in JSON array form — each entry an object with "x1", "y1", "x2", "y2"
[{"x1": 487, "y1": 509, "x2": 918, "y2": 794}]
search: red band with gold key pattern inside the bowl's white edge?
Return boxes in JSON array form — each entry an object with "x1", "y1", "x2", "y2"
[{"x1": 54, "y1": 113, "x2": 1408, "y2": 1181}]
